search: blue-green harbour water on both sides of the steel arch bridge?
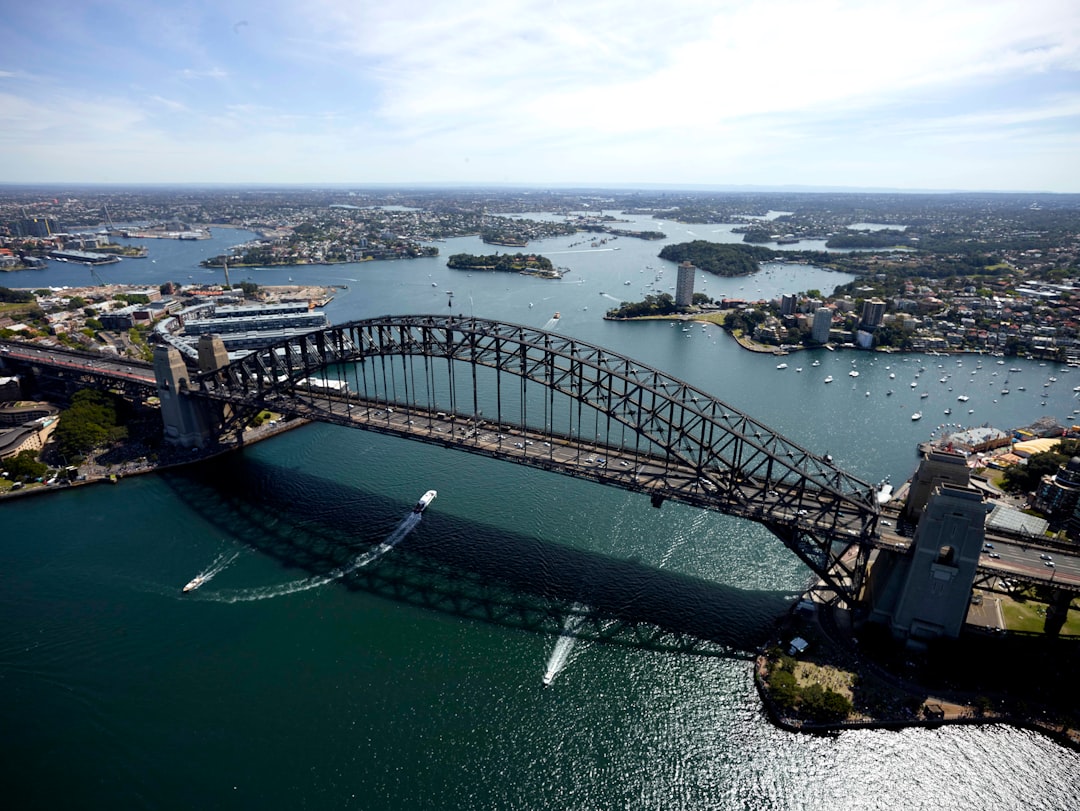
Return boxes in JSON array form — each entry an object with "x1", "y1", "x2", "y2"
[{"x1": 0, "y1": 220, "x2": 1080, "y2": 809}]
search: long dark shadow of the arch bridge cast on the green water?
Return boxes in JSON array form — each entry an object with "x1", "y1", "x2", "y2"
[{"x1": 161, "y1": 455, "x2": 791, "y2": 658}]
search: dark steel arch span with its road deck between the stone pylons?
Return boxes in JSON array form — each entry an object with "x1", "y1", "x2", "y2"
[{"x1": 192, "y1": 315, "x2": 880, "y2": 604}]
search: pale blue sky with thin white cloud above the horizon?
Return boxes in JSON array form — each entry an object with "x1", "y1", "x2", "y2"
[{"x1": 0, "y1": 0, "x2": 1080, "y2": 192}]
